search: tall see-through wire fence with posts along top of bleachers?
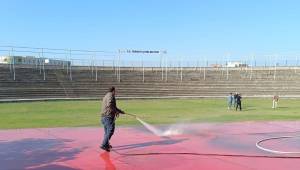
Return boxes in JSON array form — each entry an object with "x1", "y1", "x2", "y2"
[{"x1": 0, "y1": 46, "x2": 299, "y2": 81}]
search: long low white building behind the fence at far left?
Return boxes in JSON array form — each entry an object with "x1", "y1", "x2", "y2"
[{"x1": 0, "y1": 56, "x2": 71, "y2": 66}]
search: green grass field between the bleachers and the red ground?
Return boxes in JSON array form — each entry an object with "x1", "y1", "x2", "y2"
[{"x1": 0, "y1": 99, "x2": 300, "y2": 129}]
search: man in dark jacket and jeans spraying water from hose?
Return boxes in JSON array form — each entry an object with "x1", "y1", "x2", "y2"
[{"x1": 100, "y1": 87, "x2": 125, "y2": 152}]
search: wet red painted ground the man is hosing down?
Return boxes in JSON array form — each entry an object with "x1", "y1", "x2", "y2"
[{"x1": 0, "y1": 122, "x2": 300, "y2": 170}]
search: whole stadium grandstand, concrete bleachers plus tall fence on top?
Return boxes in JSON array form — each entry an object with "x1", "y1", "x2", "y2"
[{"x1": 0, "y1": 46, "x2": 300, "y2": 101}]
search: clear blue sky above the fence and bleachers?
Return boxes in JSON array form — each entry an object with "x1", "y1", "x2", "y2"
[{"x1": 0, "y1": 0, "x2": 300, "y2": 60}]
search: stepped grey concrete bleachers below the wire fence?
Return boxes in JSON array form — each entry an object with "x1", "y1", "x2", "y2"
[{"x1": 0, "y1": 66, "x2": 300, "y2": 99}]
